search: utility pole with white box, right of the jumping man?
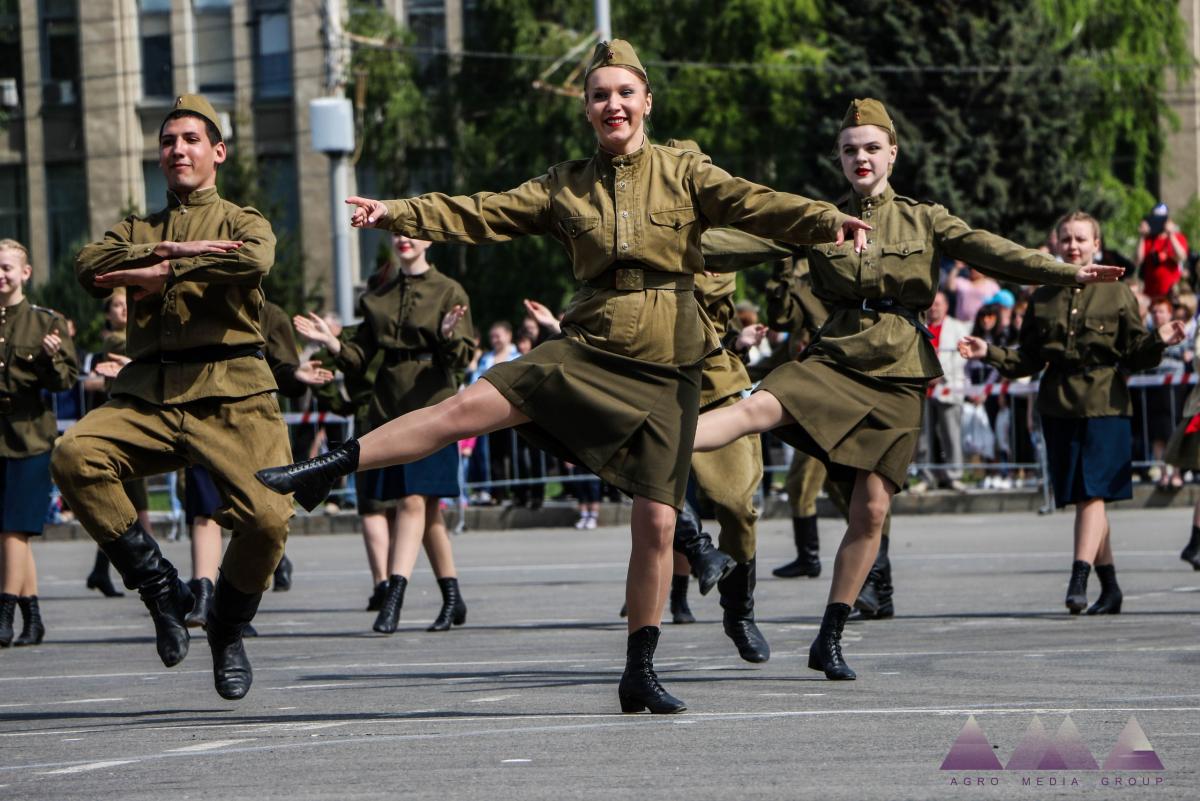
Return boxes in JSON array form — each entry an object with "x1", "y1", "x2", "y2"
[{"x1": 308, "y1": 0, "x2": 354, "y2": 325}]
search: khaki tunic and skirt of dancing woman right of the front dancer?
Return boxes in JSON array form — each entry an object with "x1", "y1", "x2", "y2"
[{"x1": 758, "y1": 187, "x2": 1076, "y2": 488}]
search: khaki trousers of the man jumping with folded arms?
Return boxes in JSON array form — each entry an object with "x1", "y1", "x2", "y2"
[{"x1": 50, "y1": 392, "x2": 293, "y2": 594}]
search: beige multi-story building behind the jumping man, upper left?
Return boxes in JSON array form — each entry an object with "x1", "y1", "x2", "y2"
[{"x1": 0, "y1": 0, "x2": 463, "y2": 303}]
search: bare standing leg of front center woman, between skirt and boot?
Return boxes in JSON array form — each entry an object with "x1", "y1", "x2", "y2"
[{"x1": 625, "y1": 496, "x2": 676, "y2": 632}]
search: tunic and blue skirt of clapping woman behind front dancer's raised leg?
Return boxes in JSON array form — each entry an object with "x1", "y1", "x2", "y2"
[{"x1": 335, "y1": 266, "x2": 474, "y2": 501}]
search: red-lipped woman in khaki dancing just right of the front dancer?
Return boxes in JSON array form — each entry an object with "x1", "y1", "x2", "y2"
[{"x1": 696, "y1": 100, "x2": 1122, "y2": 679}]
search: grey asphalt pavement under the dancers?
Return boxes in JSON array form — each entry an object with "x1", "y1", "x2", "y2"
[{"x1": 0, "y1": 510, "x2": 1200, "y2": 801}]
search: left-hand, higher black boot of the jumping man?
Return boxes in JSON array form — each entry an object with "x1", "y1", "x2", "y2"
[{"x1": 100, "y1": 523, "x2": 194, "y2": 668}]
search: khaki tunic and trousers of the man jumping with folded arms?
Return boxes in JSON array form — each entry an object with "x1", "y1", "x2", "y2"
[{"x1": 52, "y1": 188, "x2": 300, "y2": 594}]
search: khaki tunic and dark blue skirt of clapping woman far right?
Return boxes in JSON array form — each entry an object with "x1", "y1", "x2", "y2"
[{"x1": 985, "y1": 283, "x2": 1166, "y2": 507}]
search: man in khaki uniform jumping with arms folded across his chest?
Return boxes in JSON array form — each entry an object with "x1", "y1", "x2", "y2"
[{"x1": 52, "y1": 95, "x2": 292, "y2": 699}]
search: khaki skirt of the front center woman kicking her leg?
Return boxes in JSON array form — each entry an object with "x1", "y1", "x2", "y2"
[{"x1": 482, "y1": 337, "x2": 701, "y2": 508}]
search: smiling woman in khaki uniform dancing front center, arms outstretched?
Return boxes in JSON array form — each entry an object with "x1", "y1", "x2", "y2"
[{"x1": 259, "y1": 41, "x2": 866, "y2": 712}]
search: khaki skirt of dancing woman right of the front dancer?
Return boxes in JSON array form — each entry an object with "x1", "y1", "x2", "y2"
[{"x1": 758, "y1": 356, "x2": 926, "y2": 489}]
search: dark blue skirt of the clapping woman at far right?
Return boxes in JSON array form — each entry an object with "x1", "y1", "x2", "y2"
[{"x1": 1042, "y1": 417, "x2": 1133, "y2": 508}]
